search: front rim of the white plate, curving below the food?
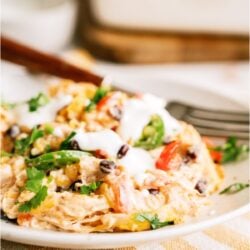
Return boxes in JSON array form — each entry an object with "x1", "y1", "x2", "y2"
[{"x1": 1, "y1": 204, "x2": 250, "y2": 248}]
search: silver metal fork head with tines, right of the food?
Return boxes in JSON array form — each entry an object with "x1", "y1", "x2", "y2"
[{"x1": 167, "y1": 101, "x2": 249, "y2": 140}]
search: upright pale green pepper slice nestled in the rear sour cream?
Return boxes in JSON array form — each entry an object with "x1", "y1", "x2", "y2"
[{"x1": 134, "y1": 115, "x2": 164, "y2": 150}]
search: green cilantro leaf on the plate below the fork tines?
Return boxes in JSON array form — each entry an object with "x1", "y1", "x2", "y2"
[{"x1": 214, "y1": 136, "x2": 249, "y2": 163}]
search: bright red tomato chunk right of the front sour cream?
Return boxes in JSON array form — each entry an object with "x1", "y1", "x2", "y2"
[{"x1": 155, "y1": 141, "x2": 181, "y2": 170}]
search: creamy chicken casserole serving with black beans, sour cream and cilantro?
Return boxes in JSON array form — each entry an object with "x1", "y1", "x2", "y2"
[{"x1": 1, "y1": 81, "x2": 223, "y2": 232}]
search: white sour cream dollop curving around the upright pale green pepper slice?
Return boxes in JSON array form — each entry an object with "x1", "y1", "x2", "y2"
[{"x1": 118, "y1": 94, "x2": 181, "y2": 141}]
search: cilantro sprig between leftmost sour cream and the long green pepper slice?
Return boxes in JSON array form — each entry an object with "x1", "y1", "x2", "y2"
[{"x1": 15, "y1": 127, "x2": 44, "y2": 155}]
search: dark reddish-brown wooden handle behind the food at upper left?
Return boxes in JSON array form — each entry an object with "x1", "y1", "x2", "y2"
[{"x1": 1, "y1": 36, "x2": 103, "y2": 86}]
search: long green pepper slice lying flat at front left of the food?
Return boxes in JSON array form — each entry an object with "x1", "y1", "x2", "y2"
[{"x1": 26, "y1": 150, "x2": 88, "y2": 171}]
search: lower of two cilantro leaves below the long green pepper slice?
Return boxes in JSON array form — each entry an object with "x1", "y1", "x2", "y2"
[{"x1": 18, "y1": 186, "x2": 48, "y2": 212}]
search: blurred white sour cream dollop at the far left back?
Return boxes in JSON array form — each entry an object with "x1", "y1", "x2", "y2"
[{"x1": 14, "y1": 95, "x2": 72, "y2": 128}]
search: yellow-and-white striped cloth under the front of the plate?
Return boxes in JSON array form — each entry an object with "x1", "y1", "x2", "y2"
[{"x1": 1, "y1": 213, "x2": 250, "y2": 250}]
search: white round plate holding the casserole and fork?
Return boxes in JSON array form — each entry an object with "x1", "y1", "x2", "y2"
[{"x1": 1, "y1": 72, "x2": 249, "y2": 249}]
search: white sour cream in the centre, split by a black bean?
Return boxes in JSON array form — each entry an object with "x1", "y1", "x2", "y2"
[{"x1": 72, "y1": 129, "x2": 154, "y2": 176}]
